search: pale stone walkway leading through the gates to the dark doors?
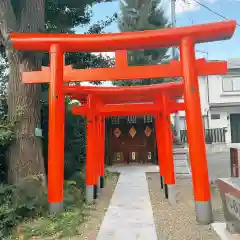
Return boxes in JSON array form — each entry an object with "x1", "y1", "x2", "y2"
[{"x1": 97, "y1": 165, "x2": 158, "y2": 240}]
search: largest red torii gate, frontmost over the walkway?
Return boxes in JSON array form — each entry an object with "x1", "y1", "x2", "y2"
[{"x1": 10, "y1": 21, "x2": 236, "y2": 224}]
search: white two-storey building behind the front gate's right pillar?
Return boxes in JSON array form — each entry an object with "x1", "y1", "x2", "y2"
[{"x1": 176, "y1": 59, "x2": 240, "y2": 143}]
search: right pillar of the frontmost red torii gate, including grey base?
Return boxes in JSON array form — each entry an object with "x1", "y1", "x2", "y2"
[{"x1": 180, "y1": 37, "x2": 213, "y2": 224}]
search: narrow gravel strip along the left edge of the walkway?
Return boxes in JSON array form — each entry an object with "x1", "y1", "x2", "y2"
[{"x1": 66, "y1": 174, "x2": 119, "y2": 240}]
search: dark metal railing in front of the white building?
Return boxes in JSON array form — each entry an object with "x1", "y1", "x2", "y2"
[{"x1": 180, "y1": 128, "x2": 226, "y2": 143}]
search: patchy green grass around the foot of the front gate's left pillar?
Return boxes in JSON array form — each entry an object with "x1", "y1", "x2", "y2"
[{"x1": 10, "y1": 171, "x2": 118, "y2": 240}]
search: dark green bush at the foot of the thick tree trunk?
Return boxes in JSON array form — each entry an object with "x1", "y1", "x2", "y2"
[{"x1": 0, "y1": 175, "x2": 47, "y2": 239}]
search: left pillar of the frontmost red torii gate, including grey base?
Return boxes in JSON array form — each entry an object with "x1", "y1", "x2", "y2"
[{"x1": 48, "y1": 44, "x2": 65, "y2": 213}]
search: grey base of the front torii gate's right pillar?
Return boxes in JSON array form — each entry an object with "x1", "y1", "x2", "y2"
[{"x1": 195, "y1": 200, "x2": 213, "y2": 225}]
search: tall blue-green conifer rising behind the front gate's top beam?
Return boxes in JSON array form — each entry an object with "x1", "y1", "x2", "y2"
[{"x1": 114, "y1": 0, "x2": 169, "y2": 86}]
